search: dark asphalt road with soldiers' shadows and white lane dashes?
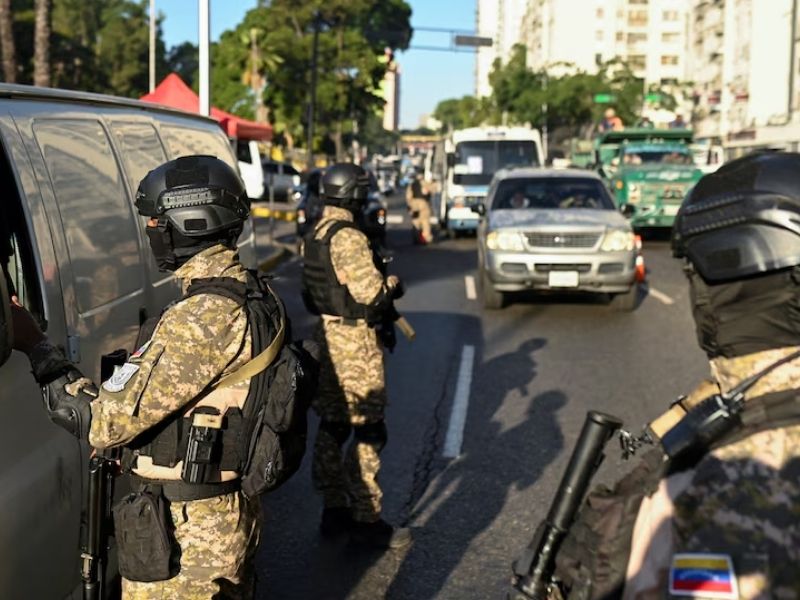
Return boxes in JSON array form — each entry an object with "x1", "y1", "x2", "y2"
[{"x1": 250, "y1": 198, "x2": 707, "y2": 600}]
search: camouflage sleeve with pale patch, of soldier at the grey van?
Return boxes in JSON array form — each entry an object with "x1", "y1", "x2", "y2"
[{"x1": 89, "y1": 295, "x2": 247, "y2": 448}]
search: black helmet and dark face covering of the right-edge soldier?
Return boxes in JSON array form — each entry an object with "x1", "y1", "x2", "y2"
[{"x1": 672, "y1": 152, "x2": 800, "y2": 358}]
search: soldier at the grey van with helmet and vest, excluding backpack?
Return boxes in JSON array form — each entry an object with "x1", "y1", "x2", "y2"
[{"x1": 13, "y1": 156, "x2": 288, "y2": 600}]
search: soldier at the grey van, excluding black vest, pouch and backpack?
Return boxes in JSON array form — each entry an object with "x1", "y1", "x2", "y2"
[{"x1": 14, "y1": 157, "x2": 270, "y2": 600}]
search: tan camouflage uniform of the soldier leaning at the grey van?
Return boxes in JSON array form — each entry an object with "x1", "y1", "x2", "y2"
[{"x1": 89, "y1": 245, "x2": 261, "y2": 600}]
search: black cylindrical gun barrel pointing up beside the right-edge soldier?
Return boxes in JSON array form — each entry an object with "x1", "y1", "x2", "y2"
[{"x1": 506, "y1": 411, "x2": 622, "y2": 600}]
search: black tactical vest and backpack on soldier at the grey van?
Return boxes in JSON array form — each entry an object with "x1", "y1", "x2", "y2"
[{"x1": 122, "y1": 272, "x2": 310, "y2": 500}]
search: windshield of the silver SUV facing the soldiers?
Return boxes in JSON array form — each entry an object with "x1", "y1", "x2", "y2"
[{"x1": 492, "y1": 177, "x2": 614, "y2": 210}]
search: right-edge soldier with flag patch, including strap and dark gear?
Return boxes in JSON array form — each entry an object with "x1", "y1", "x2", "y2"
[{"x1": 556, "y1": 153, "x2": 800, "y2": 600}]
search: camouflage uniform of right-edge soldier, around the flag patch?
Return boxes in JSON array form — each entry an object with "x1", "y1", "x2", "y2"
[{"x1": 623, "y1": 348, "x2": 800, "y2": 599}]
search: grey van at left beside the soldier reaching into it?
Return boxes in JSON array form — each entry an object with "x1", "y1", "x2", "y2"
[{"x1": 0, "y1": 84, "x2": 255, "y2": 599}]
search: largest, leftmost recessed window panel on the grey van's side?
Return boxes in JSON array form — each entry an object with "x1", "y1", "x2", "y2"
[{"x1": 33, "y1": 119, "x2": 142, "y2": 313}]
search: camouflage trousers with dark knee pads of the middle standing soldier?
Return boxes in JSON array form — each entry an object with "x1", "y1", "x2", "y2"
[{"x1": 312, "y1": 322, "x2": 386, "y2": 521}]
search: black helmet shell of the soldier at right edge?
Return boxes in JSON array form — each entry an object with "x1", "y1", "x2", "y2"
[{"x1": 672, "y1": 152, "x2": 800, "y2": 282}]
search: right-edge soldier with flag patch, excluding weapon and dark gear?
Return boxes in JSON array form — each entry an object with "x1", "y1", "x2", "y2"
[{"x1": 623, "y1": 154, "x2": 800, "y2": 599}]
